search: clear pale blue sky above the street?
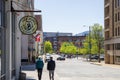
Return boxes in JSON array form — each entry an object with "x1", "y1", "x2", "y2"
[{"x1": 35, "y1": 0, "x2": 104, "y2": 34}]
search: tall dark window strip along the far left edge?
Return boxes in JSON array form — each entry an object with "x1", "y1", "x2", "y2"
[{"x1": 0, "y1": 0, "x2": 5, "y2": 80}]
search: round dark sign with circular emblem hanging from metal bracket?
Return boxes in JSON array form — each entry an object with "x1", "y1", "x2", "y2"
[{"x1": 19, "y1": 16, "x2": 38, "y2": 35}]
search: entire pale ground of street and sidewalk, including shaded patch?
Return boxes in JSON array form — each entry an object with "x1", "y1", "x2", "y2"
[{"x1": 22, "y1": 55, "x2": 120, "y2": 80}]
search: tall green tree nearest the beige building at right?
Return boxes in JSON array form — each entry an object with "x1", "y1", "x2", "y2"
[{"x1": 80, "y1": 23, "x2": 104, "y2": 59}]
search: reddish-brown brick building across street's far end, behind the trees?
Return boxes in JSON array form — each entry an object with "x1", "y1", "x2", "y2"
[{"x1": 45, "y1": 36, "x2": 86, "y2": 53}]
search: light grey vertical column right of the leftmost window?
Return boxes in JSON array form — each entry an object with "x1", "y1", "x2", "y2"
[{"x1": 5, "y1": 1, "x2": 12, "y2": 80}]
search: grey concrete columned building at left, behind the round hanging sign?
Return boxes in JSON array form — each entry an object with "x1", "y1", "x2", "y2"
[{"x1": 0, "y1": 0, "x2": 34, "y2": 80}]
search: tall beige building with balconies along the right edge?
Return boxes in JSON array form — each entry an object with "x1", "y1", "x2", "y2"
[{"x1": 104, "y1": 0, "x2": 120, "y2": 64}]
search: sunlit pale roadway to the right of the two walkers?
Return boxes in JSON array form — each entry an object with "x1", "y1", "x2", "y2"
[{"x1": 56, "y1": 59, "x2": 120, "y2": 80}]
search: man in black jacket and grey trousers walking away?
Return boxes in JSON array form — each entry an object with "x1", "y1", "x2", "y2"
[{"x1": 47, "y1": 57, "x2": 55, "y2": 80}]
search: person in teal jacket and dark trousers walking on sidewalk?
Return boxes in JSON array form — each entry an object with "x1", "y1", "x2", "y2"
[{"x1": 36, "y1": 56, "x2": 44, "y2": 80}]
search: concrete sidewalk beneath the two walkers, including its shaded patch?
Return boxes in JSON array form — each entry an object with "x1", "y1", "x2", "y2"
[{"x1": 21, "y1": 63, "x2": 59, "y2": 80}]
